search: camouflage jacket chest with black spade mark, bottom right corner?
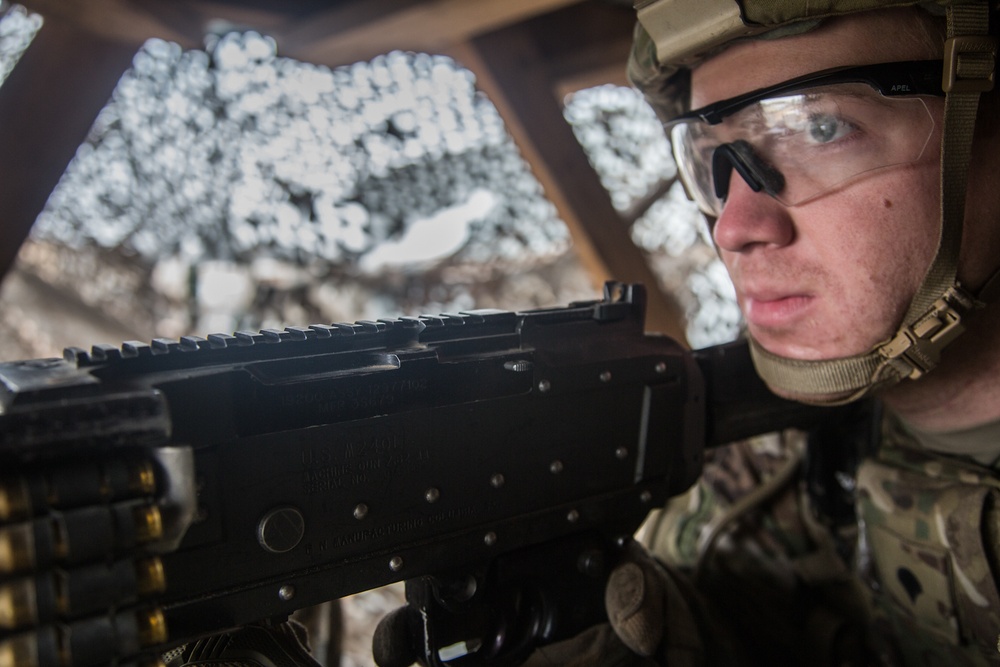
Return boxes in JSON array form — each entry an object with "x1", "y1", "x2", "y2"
[{"x1": 857, "y1": 422, "x2": 1000, "y2": 665}]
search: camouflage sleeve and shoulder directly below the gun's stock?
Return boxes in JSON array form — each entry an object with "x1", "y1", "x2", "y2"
[{"x1": 642, "y1": 431, "x2": 865, "y2": 665}]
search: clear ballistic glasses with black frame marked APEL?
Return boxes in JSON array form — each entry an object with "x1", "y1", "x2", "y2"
[{"x1": 667, "y1": 60, "x2": 944, "y2": 217}]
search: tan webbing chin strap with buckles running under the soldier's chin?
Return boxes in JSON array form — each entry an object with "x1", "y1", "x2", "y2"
[{"x1": 750, "y1": 0, "x2": 1000, "y2": 405}]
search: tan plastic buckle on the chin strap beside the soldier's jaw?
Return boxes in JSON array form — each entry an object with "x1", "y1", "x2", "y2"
[{"x1": 879, "y1": 285, "x2": 983, "y2": 380}]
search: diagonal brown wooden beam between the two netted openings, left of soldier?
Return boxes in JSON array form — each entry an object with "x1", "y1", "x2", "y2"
[{"x1": 451, "y1": 9, "x2": 685, "y2": 341}]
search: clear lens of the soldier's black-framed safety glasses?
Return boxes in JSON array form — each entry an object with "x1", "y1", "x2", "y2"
[{"x1": 670, "y1": 83, "x2": 935, "y2": 217}]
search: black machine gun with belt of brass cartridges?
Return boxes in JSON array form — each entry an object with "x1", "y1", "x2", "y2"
[{"x1": 0, "y1": 283, "x2": 860, "y2": 667}]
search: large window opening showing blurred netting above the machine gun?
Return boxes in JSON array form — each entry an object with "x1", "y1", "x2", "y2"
[{"x1": 1, "y1": 32, "x2": 594, "y2": 360}]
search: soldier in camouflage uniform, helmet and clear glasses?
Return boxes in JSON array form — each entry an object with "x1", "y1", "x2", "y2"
[{"x1": 572, "y1": 0, "x2": 1000, "y2": 665}]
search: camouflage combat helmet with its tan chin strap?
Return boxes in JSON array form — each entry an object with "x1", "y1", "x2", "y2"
[{"x1": 629, "y1": 0, "x2": 1000, "y2": 404}]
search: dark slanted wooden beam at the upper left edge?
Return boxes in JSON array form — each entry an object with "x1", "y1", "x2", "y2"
[{"x1": 0, "y1": 13, "x2": 136, "y2": 278}]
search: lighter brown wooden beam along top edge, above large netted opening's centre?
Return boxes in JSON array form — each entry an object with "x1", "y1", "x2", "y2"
[{"x1": 273, "y1": 0, "x2": 581, "y2": 67}]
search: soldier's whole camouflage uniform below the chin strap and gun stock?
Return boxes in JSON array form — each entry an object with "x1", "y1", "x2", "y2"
[{"x1": 644, "y1": 421, "x2": 1000, "y2": 665}]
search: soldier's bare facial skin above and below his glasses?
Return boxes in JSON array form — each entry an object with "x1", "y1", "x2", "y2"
[{"x1": 692, "y1": 12, "x2": 942, "y2": 359}]
